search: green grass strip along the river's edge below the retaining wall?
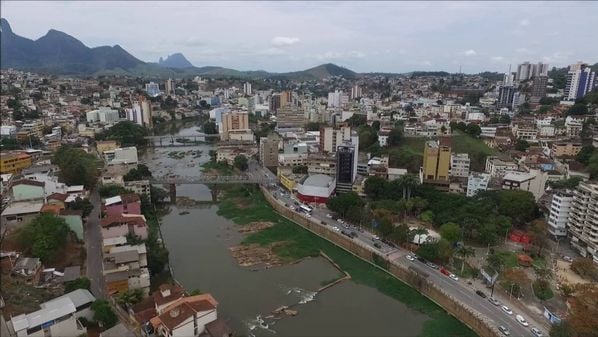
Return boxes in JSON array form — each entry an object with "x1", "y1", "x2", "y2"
[{"x1": 218, "y1": 186, "x2": 476, "y2": 337}]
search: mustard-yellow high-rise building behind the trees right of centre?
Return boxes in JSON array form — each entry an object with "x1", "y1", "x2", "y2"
[{"x1": 421, "y1": 138, "x2": 451, "y2": 189}]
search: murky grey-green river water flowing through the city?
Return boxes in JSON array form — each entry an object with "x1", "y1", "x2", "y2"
[{"x1": 142, "y1": 121, "x2": 429, "y2": 336}]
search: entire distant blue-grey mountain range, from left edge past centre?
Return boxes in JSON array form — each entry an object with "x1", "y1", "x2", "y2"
[{"x1": 0, "y1": 18, "x2": 357, "y2": 81}]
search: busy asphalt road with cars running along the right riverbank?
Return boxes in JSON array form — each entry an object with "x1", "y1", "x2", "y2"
[{"x1": 247, "y1": 161, "x2": 548, "y2": 337}]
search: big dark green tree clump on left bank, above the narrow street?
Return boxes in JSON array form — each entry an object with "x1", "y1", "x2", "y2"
[{"x1": 52, "y1": 145, "x2": 98, "y2": 188}]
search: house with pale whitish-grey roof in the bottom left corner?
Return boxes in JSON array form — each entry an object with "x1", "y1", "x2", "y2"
[{"x1": 10, "y1": 296, "x2": 87, "y2": 337}]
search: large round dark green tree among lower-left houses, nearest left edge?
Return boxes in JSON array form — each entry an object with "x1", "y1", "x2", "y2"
[{"x1": 17, "y1": 213, "x2": 70, "y2": 263}]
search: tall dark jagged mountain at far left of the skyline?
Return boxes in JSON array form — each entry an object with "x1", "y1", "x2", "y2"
[{"x1": 0, "y1": 19, "x2": 143, "y2": 74}]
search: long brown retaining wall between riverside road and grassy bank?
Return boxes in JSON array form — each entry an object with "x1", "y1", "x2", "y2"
[{"x1": 261, "y1": 187, "x2": 500, "y2": 337}]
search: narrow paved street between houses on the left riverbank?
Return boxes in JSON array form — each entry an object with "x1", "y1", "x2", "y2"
[{"x1": 85, "y1": 189, "x2": 106, "y2": 298}]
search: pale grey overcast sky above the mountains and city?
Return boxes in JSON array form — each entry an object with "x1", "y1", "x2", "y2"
[{"x1": 0, "y1": 1, "x2": 598, "y2": 73}]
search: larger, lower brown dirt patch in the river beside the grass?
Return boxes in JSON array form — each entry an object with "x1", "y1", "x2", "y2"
[{"x1": 229, "y1": 242, "x2": 284, "y2": 270}]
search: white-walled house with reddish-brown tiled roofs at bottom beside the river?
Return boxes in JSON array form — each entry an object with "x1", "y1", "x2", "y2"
[{"x1": 150, "y1": 294, "x2": 218, "y2": 337}]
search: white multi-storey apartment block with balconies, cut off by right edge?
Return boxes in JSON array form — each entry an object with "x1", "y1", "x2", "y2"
[{"x1": 567, "y1": 182, "x2": 598, "y2": 264}]
